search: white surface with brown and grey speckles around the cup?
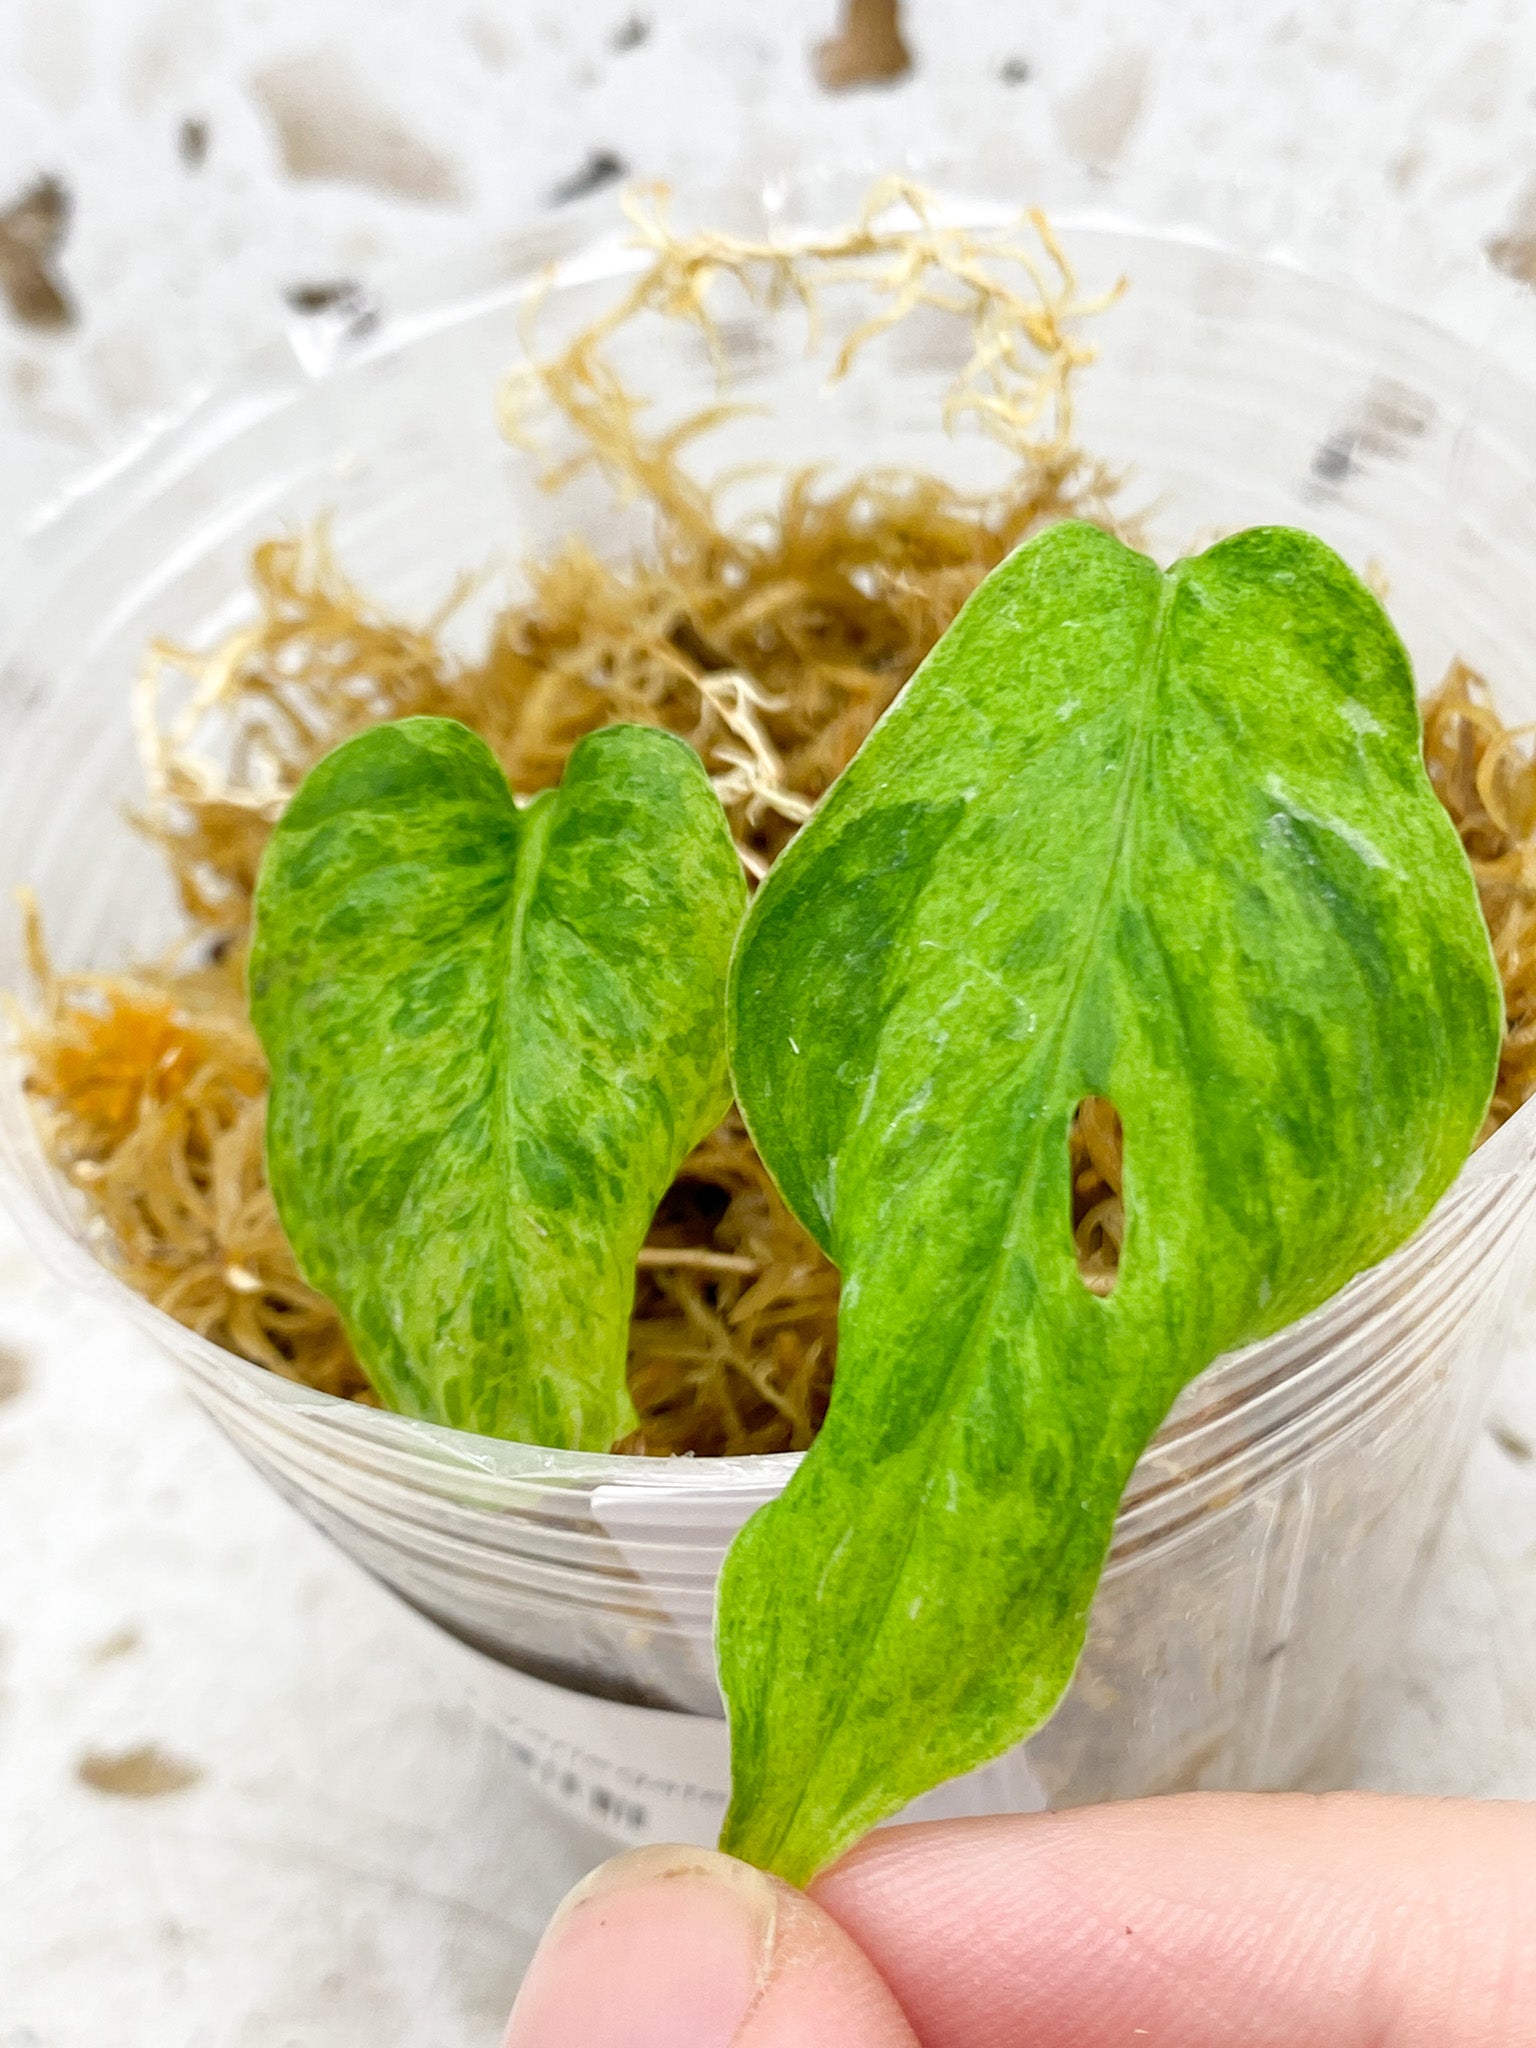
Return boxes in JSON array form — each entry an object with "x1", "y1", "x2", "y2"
[{"x1": 0, "y1": 0, "x2": 1536, "y2": 2048}]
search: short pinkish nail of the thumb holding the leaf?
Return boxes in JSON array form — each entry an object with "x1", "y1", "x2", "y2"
[{"x1": 504, "y1": 1847, "x2": 776, "y2": 2048}]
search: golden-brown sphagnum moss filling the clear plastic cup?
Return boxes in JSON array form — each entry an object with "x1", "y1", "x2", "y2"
[{"x1": 23, "y1": 182, "x2": 1536, "y2": 1456}]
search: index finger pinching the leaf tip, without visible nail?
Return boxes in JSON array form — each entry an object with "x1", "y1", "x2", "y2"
[{"x1": 813, "y1": 1794, "x2": 1536, "y2": 2048}]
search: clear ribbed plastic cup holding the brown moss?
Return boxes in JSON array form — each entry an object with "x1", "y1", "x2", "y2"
[{"x1": 0, "y1": 172, "x2": 1536, "y2": 1839}]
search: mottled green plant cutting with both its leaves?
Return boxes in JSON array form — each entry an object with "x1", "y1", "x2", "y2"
[{"x1": 240, "y1": 522, "x2": 1503, "y2": 1882}]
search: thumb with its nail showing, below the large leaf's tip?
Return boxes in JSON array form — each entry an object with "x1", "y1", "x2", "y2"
[{"x1": 504, "y1": 1849, "x2": 918, "y2": 2048}]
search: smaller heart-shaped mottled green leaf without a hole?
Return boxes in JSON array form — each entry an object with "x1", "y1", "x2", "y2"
[{"x1": 250, "y1": 719, "x2": 745, "y2": 1450}]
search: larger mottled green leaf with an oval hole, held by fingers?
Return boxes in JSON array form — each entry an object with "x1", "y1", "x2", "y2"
[{"x1": 719, "y1": 524, "x2": 1501, "y2": 1880}]
